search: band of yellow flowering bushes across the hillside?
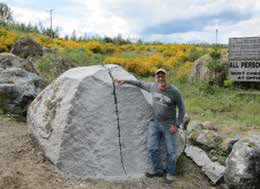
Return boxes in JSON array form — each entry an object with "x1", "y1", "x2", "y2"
[{"x1": 0, "y1": 28, "x2": 207, "y2": 79}]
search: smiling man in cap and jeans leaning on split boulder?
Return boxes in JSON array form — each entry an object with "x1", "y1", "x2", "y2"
[{"x1": 114, "y1": 68, "x2": 185, "y2": 184}]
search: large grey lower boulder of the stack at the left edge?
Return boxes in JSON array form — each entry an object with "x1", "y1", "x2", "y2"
[{"x1": 0, "y1": 68, "x2": 45, "y2": 115}]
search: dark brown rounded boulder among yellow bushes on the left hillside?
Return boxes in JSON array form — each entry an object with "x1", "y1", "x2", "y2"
[{"x1": 11, "y1": 37, "x2": 43, "y2": 58}]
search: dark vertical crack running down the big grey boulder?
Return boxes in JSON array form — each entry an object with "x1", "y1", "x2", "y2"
[{"x1": 108, "y1": 69, "x2": 127, "y2": 175}]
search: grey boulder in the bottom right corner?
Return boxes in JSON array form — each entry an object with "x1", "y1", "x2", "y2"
[{"x1": 224, "y1": 134, "x2": 260, "y2": 189}]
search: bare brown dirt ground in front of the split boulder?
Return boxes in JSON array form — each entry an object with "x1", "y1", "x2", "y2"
[{"x1": 0, "y1": 116, "x2": 211, "y2": 189}]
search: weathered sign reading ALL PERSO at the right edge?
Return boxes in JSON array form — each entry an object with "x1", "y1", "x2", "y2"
[{"x1": 228, "y1": 37, "x2": 260, "y2": 82}]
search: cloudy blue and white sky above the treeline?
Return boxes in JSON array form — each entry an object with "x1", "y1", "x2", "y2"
[{"x1": 3, "y1": 0, "x2": 260, "y2": 43}]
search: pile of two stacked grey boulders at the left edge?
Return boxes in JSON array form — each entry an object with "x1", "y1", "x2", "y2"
[{"x1": 0, "y1": 53, "x2": 45, "y2": 115}]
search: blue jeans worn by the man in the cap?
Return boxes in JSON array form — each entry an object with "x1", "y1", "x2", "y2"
[{"x1": 150, "y1": 120, "x2": 176, "y2": 175}]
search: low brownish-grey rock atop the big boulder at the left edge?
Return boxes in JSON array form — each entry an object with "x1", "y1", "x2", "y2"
[{"x1": 0, "y1": 52, "x2": 37, "y2": 74}]
